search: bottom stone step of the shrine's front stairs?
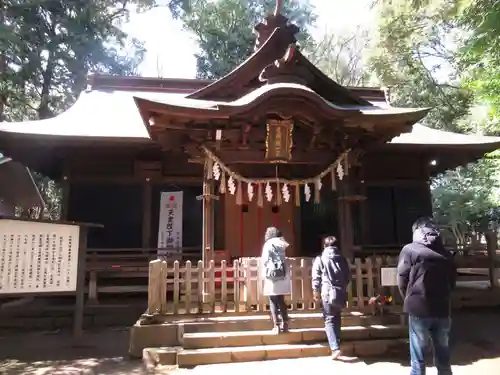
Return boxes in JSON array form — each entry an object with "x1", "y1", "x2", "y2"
[{"x1": 143, "y1": 339, "x2": 407, "y2": 367}]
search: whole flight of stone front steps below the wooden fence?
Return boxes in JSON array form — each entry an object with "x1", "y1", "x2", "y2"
[{"x1": 135, "y1": 312, "x2": 407, "y2": 367}]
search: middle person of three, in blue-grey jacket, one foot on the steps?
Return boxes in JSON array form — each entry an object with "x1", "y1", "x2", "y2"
[{"x1": 312, "y1": 236, "x2": 351, "y2": 360}]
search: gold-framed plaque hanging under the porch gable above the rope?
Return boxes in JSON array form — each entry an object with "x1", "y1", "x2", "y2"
[{"x1": 266, "y1": 119, "x2": 293, "y2": 163}]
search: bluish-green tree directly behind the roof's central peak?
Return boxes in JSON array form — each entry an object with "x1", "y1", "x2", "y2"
[{"x1": 181, "y1": 0, "x2": 316, "y2": 79}]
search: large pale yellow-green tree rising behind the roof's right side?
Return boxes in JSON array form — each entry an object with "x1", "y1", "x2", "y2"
[{"x1": 370, "y1": 0, "x2": 473, "y2": 131}]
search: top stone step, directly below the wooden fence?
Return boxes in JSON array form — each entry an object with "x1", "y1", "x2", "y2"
[{"x1": 182, "y1": 312, "x2": 401, "y2": 333}]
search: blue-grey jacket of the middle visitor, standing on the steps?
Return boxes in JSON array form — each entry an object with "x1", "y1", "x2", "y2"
[{"x1": 312, "y1": 246, "x2": 351, "y2": 307}]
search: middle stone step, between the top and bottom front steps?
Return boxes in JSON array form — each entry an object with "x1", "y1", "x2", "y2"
[{"x1": 182, "y1": 325, "x2": 408, "y2": 349}]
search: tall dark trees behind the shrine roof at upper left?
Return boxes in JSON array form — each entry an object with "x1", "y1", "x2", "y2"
[{"x1": 0, "y1": 0, "x2": 154, "y2": 218}]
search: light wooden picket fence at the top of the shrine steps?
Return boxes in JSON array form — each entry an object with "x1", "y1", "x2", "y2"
[{"x1": 147, "y1": 257, "x2": 400, "y2": 316}]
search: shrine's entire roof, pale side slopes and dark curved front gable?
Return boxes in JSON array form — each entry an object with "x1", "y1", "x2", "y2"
[{"x1": 0, "y1": 4, "x2": 500, "y2": 172}]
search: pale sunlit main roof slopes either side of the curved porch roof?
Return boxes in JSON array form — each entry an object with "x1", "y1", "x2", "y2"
[{"x1": 0, "y1": 84, "x2": 500, "y2": 152}]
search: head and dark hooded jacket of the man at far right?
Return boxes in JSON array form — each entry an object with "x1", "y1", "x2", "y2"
[{"x1": 397, "y1": 227, "x2": 456, "y2": 318}]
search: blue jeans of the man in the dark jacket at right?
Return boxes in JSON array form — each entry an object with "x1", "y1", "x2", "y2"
[{"x1": 408, "y1": 315, "x2": 452, "y2": 375}]
